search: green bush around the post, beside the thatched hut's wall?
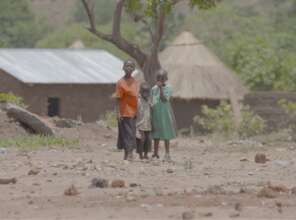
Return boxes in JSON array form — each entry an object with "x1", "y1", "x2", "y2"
[{"x1": 194, "y1": 102, "x2": 265, "y2": 138}]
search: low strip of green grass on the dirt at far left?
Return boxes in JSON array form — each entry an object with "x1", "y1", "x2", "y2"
[{"x1": 0, "y1": 135, "x2": 79, "y2": 150}]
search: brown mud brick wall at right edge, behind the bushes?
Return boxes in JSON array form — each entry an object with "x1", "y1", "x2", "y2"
[{"x1": 244, "y1": 92, "x2": 296, "y2": 131}]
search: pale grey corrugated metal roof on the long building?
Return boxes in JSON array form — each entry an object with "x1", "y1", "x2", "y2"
[{"x1": 0, "y1": 49, "x2": 123, "y2": 84}]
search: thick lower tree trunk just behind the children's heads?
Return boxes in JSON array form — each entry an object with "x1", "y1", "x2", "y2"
[{"x1": 142, "y1": 53, "x2": 161, "y2": 86}]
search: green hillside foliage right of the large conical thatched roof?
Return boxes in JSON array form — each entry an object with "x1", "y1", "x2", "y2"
[{"x1": 185, "y1": 0, "x2": 296, "y2": 91}]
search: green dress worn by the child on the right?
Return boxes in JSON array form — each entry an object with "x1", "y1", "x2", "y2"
[{"x1": 151, "y1": 85, "x2": 177, "y2": 140}]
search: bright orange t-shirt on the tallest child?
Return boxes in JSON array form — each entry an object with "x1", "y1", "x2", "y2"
[{"x1": 115, "y1": 77, "x2": 138, "y2": 118}]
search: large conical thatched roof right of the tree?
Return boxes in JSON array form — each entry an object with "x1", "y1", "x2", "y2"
[{"x1": 160, "y1": 32, "x2": 247, "y2": 100}]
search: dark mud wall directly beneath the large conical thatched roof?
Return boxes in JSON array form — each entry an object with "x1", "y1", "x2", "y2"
[{"x1": 172, "y1": 98, "x2": 220, "y2": 129}]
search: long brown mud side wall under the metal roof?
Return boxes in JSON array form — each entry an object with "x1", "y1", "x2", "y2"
[{"x1": 23, "y1": 84, "x2": 115, "y2": 122}]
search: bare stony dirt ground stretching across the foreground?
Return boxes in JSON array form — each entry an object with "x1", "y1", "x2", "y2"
[{"x1": 0, "y1": 120, "x2": 296, "y2": 220}]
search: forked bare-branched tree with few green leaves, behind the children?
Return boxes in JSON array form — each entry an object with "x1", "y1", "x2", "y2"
[{"x1": 81, "y1": 0, "x2": 219, "y2": 83}]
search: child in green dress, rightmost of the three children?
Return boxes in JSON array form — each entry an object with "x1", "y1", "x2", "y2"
[{"x1": 151, "y1": 70, "x2": 177, "y2": 161}]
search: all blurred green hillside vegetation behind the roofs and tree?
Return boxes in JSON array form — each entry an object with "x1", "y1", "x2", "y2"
[{"x1": 0, "y1": 0, "x2": 296, "y2": 91}]
